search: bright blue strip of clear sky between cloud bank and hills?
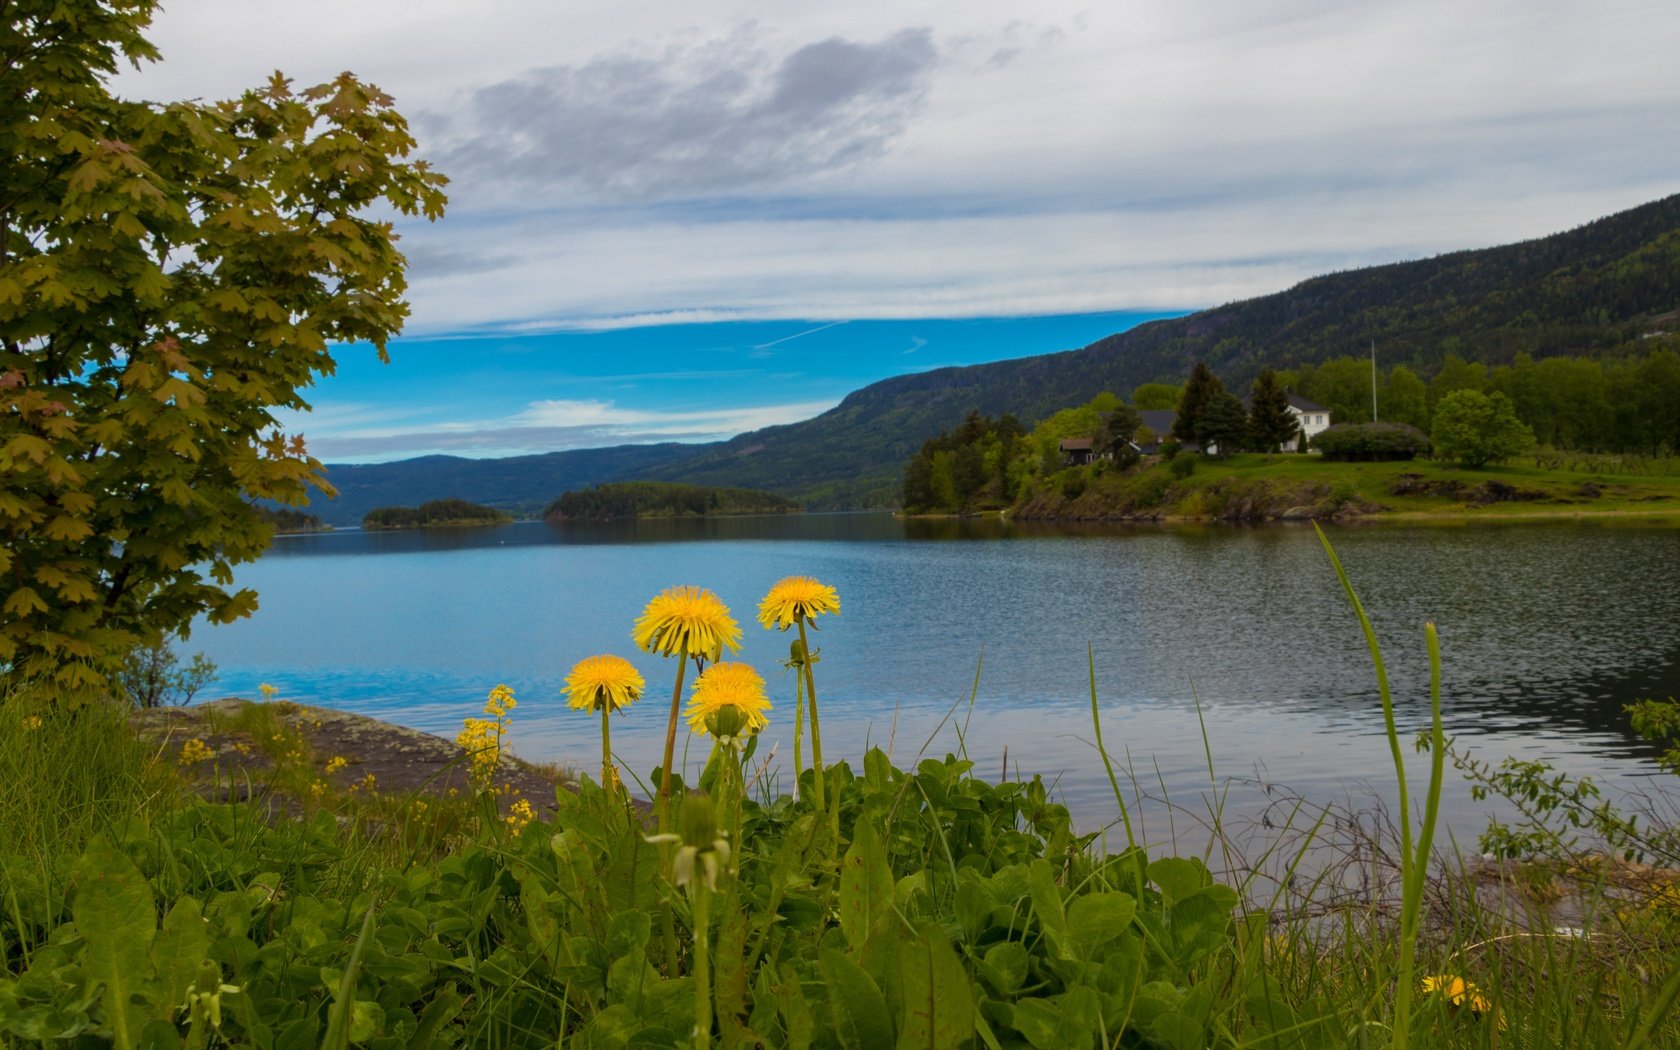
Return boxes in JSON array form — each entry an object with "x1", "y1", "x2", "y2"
[{"x1": 286, "y1": 311, "x2": 1176, "y2": 462}]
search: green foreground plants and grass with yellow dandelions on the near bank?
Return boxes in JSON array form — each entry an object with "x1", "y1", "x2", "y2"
[{"x1": 0, "y1": 554, "x2": 1680, "y2": 1048}]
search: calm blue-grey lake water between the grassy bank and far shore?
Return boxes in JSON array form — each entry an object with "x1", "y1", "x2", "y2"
[{"x1": 185, "y1": 514, "x2": 1680, "y2": 840}]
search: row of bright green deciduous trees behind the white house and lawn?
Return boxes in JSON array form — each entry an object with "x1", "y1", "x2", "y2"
[{"x1": 1278, "y1": 347, "x2": 1680, "y2": 455}]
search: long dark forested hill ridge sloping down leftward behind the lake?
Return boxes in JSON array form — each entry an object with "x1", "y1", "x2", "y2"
[{"x1": 311, "y1": 195, "x2": 1680, "y2": 522}]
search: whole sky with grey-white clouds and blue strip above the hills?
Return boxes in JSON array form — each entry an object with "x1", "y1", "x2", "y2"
[{"x1": 118, "y1": 0, "x2": 1680, "y2": 462}]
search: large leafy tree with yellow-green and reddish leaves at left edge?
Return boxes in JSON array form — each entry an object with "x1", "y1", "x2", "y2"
[{"x1": 0, "y1": 0, "x2": 445, "y2": 697}]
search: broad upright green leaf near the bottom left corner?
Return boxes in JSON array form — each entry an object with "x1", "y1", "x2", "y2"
[{"x1": 71, "y1": 837, "x2": 158, "y2": 1050}]
